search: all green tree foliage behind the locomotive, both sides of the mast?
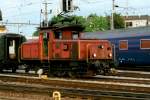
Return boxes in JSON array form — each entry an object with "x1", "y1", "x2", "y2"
[{"x1": 33, "y1": 13, "x2": 125, "y2": 36}]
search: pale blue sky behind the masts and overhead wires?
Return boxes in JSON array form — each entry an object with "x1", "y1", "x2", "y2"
[{"x1": 0, "y1": 0, "x2": 150, "y2": 36}]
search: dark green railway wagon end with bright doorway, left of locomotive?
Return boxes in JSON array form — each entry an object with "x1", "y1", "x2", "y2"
[{"x1": 0, "y1": 33, "x2": 26, "y2": 72}]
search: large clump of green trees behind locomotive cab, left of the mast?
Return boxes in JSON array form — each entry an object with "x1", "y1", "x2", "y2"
[{"x1": 49, "y1": 14, "x2": 109, "y2": 32}]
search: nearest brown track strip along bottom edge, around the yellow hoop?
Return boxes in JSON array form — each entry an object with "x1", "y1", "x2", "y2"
[{"x1": 0, "y1": 86, "x2": 150, "y2": 100}]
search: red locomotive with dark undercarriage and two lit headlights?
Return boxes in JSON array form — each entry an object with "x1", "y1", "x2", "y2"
[{"x1": 21, "y1": 26, "x2": 113, "y2": 76}]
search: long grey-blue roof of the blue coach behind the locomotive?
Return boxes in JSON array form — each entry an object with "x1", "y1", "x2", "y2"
[{"x1": 81, "y1": 26, "x2": 150, "y2": 39}]
